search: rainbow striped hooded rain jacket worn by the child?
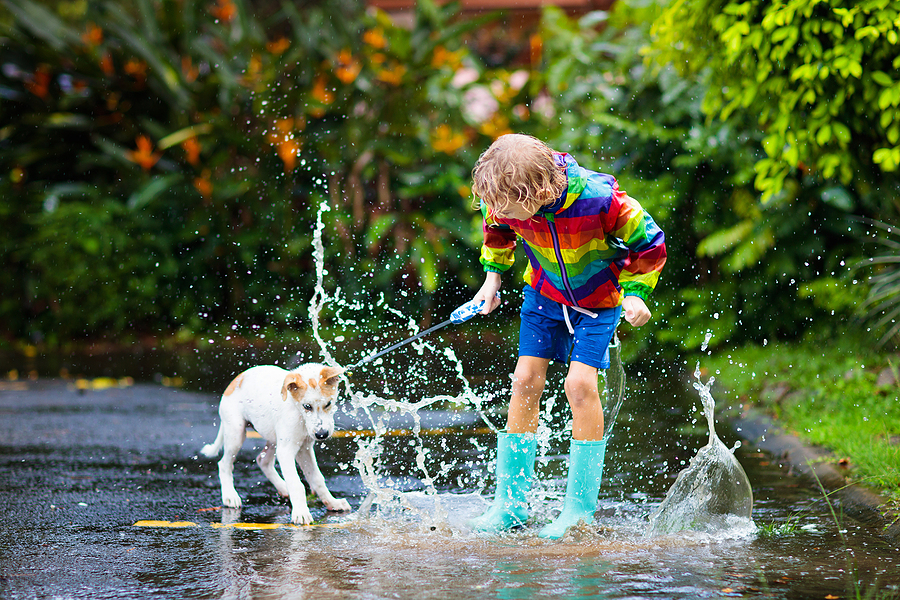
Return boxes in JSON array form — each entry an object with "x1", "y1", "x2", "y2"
[{"x1": 481, "y1": 153, "x2": 666, "y2": 309}]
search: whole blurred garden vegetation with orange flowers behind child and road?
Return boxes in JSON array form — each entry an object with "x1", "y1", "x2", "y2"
[{"x1": 0, "y1": 0, "x2": 900, "y2": 356}]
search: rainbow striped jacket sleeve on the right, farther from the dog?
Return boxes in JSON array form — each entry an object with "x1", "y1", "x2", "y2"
[{"x1": 609, "y1": 183, "x2": 666, "y2": 300}]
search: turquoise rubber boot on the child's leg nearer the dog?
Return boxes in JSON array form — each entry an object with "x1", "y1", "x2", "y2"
[{"x1": 469, "y1": 432, "x2": 537, "y2": 533}]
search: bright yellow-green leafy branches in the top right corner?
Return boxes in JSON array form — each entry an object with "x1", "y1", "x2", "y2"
[{"x1": 654, "y1": 0, "x2": 900, "y2": 201}]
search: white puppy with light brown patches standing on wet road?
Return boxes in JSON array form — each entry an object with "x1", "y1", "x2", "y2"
[{"x1": 200, "y1": 363, "x2": 350, "y2": 525}]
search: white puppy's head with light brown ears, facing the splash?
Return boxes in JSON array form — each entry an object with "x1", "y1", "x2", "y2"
[{"x1": 281, "y1": 364, "x2": 344, "y2": 440}]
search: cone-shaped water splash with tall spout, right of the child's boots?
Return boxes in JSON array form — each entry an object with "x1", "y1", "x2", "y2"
[{"x1": 648, "y1": 356, "x2": 755, "y2": 536}]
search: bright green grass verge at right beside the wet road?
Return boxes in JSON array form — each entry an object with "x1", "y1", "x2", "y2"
[{"x1": 701, "y1": 332, "x2": 900, "y2": 501}]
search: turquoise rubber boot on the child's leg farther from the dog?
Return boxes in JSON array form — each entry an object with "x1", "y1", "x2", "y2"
[{"x1": 538, "y1": 438, "x2": 606, "y2": 540}]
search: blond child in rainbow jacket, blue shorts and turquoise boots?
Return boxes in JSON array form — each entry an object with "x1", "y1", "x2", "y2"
[{"x1": 471, "y1": 134, "x2": 666, "y2": 539}]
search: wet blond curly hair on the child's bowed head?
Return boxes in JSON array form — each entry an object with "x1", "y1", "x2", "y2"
[{"x1": 472, "y1": 133, "x2": 568, "y2": 217}]
